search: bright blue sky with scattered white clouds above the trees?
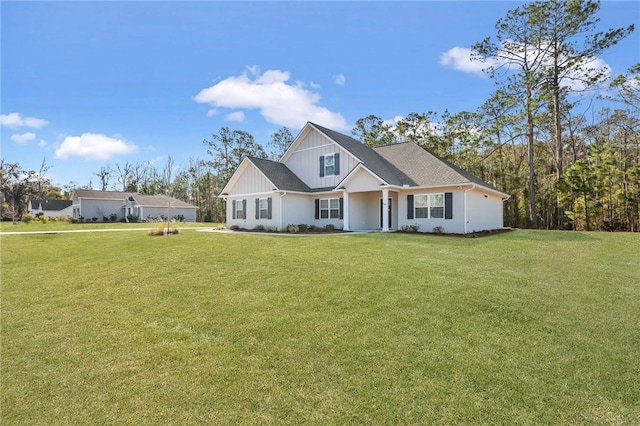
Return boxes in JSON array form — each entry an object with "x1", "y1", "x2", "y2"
[{"x1": 0, "y1": 1, "x2": 640, "y2": 185}]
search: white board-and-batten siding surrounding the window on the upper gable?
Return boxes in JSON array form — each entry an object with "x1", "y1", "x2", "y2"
[{"x1": 285, "y1": 132, "x2": 358, "y2": 188}]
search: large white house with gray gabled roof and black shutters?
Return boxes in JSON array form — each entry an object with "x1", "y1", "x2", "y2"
[{"x1": 222, "y1": 123, "x2": 508, "y2": 234}]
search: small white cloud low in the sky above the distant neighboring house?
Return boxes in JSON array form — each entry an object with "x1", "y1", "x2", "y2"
[{"x1": 56, "y1": 133, "x2": 138, "y2": 161}]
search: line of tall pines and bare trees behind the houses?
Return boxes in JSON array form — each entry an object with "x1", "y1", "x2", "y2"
[{"x1": 0, "y1": 0, "x2": 640, "y2": 232}]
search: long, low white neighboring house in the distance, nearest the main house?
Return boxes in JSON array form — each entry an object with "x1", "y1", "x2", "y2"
[{"x1": 71, "y1": 189, "x2": 197, "y2": 222}]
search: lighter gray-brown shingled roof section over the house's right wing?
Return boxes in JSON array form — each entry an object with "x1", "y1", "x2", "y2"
[{"x1": 374, "y1": 142, "x2": 497, "y2": 191}]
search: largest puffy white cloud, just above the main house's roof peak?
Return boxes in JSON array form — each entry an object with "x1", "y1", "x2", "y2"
[{"x1": 193, "y1": 66, "x2": 348, "y2": 130}]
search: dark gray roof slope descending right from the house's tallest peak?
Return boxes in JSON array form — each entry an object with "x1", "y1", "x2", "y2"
[{"x1": 309, "y1": 123, "x2": 413, "y2": 185}]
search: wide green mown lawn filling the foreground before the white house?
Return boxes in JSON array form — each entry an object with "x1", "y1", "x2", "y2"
[{"x1": 0, "y1": 228, "x2": 640, "y2": 425}]
